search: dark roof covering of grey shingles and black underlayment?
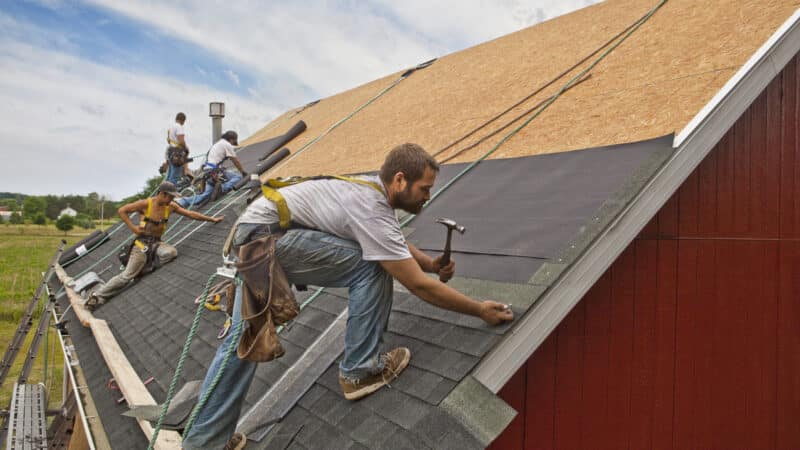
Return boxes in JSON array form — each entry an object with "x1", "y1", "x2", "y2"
[{"x1": 54, "y1": 132, "x2": 672, "y2": 449}]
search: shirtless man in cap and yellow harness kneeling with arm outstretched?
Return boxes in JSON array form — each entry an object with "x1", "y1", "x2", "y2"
[{"x1": 86, "y1": 181, "x2": 224, "y2": 309}]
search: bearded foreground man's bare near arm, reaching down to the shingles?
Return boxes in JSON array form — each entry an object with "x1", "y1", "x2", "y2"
[{"x1": 380, "y1": 258, "x2": 514, "y2": 325}]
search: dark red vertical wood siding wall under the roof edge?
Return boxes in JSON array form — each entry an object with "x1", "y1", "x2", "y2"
[{"x1": 491, "y1": 57, "x2": 800, "y2": 449}]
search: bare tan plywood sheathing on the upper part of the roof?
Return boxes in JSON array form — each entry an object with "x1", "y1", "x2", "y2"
[{"x1": 242, "y1": 0, "x2": 800, "y2": 176}]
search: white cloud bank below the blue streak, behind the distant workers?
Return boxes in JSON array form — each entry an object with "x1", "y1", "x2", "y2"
[{"x1": 0, "y1": 13, "x2": 281, "y2": 199}]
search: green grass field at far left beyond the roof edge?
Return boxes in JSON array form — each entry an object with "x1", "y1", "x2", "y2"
[{"x1": 0, "y1": 224, "x2": 91, "y2": 409}]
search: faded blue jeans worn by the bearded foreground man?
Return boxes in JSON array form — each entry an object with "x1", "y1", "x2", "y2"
[{"x1": 183, "y1": 224, "x2": 392, "y2": 450}]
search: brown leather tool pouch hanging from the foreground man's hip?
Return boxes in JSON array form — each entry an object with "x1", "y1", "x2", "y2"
[{"x1": 236, "y1": 234, "x2": 300, "y2": 362}]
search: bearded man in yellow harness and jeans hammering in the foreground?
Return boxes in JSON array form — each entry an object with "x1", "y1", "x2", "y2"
[{"x1": 183, "y1": 144, "x2": 513, "y2": 449}]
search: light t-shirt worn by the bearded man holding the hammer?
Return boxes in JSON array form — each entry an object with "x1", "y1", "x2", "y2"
[{"x1": 239, "y1": 176, "x2": 411, "y2": 261}]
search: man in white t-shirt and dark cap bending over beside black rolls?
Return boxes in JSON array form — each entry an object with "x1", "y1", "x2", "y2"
[{"x1": 177, "y1": 130, "x2": 247, "y2": 208}]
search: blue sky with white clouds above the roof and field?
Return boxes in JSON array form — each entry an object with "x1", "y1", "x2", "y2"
[{"x1": 0, "y1": 0, "x2": 596, "y2": 200}]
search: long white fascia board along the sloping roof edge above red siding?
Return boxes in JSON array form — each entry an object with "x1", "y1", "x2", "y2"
[{"x1": 472, "y1": 10, "x2": 800, "y2": 393}]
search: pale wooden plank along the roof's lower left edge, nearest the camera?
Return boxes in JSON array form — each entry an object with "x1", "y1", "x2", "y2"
[{"x1": 90, "y1": 319, "x2": 181, "y2": 449}]
